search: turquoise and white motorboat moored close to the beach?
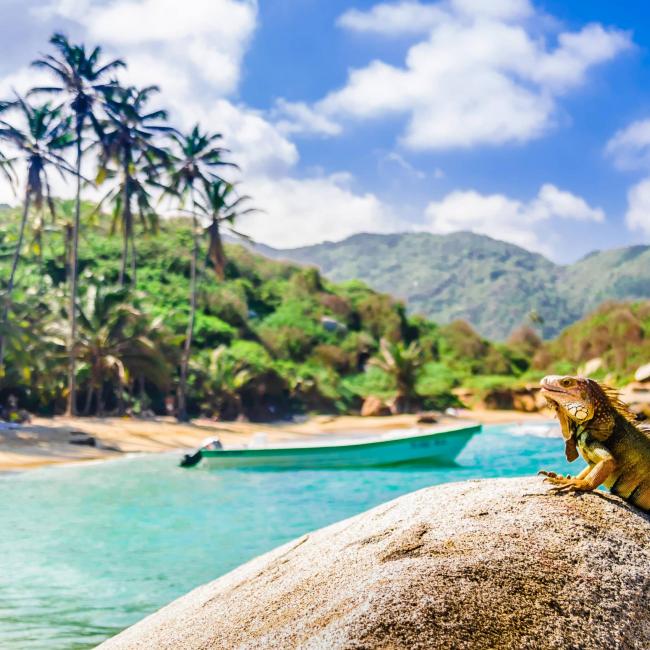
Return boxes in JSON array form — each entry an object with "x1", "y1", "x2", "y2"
[{"x1": 195, "y1": 424, "x2": 481, "y2": 469}]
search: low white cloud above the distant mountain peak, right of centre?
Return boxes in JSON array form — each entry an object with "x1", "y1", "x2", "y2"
[{"x1": 425, "y1": 184, "x2": 605, "y2": 254}]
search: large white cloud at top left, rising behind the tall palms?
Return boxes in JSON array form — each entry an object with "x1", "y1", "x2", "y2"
[{"x1": 31, "y1": 0, "x2": 298, "y2": 175}]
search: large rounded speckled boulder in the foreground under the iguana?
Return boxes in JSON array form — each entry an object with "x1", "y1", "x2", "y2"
[{"x1": 101, "y1": 476, "x2": 650, "y2": 650}]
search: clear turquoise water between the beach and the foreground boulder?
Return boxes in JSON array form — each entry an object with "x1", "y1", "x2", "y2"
[{"x1": 0, "y1": 427, "x2": 568, "y2": 650}]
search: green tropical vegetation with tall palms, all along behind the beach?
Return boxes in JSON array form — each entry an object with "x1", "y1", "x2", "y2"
[{"x1": 0, "y1": 35, "x2": 650, "y2": 420}]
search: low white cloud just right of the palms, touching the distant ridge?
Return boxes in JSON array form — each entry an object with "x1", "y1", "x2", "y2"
[{"x1": 240, "y1": 174, "x2": 396, "y2": 248}]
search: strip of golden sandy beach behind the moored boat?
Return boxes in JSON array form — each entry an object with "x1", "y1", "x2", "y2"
[{"x1": 0, "y1": 410, "x2": 551, "y2": 474}]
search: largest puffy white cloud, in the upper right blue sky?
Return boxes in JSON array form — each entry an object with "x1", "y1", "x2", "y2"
[{"x1": 314, "y1": 0, "x2": 631, "y2": 150}]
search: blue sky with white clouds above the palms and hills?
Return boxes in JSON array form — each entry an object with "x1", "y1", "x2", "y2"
[{"x1": 0, "y1": 0, "x2": 650, "y2": 262}]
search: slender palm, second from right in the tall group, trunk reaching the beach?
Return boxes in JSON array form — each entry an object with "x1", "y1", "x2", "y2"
[{"x1": 167, "y1": 124, "x2": 236, "y2": 420}]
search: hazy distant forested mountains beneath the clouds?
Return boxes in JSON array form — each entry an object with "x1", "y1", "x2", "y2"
[{"x1": 246, "y1": 232, "x2": 650, "y2": 340}]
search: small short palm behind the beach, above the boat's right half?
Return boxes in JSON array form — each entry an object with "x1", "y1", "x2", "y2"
[{"x1": 369, "y1": 338, "x2": 424, "y2": 413}]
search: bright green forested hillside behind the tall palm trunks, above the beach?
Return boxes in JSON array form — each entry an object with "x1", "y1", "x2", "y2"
[{"x1": 0, "y1": 209, "x2": 535, "y2": 420}]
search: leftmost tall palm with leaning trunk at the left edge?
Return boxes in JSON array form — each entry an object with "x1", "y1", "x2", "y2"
[{"x1": 0, "y1": 97, "x2": 76, "y2": 368}]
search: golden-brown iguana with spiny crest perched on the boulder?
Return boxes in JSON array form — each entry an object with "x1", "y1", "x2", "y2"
[{"x1": 540, "y1": 375, "x2": 650, "y2": 511}]
